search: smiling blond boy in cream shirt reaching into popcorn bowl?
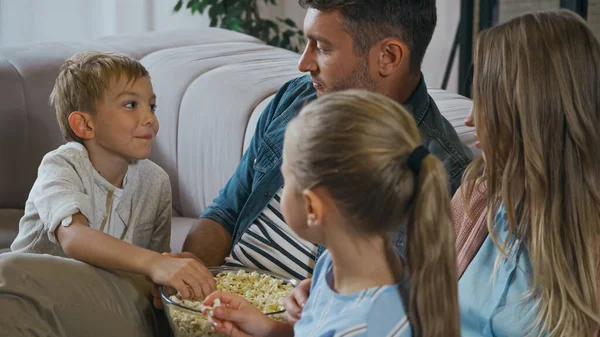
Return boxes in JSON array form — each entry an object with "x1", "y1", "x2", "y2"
[{"x1": 0, "y1": 52, "x2": 212, "y2": 336}]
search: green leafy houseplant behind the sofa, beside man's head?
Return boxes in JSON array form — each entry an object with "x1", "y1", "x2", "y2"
[{"x1": 173, "y1": 0, "x2": 306, "y2": 52}]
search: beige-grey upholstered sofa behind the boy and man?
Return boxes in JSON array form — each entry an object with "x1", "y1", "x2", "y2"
[{"x1": 0, "y1": 28, "x2": 473, "y2": 252}]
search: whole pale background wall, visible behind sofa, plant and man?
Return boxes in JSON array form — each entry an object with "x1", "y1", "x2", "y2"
[{"x1": 0, "y1": 0, "x2": 460, "y2": 91}]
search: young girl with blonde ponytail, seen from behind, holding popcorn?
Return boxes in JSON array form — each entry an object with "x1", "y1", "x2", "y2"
[{"x1": 199, "y1": 91, "x2": 460, "y2": 337}]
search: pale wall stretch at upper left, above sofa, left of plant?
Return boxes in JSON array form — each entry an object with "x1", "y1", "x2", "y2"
[{"x1": 0, "y1": 0, "x2": 208, "y2": 46}]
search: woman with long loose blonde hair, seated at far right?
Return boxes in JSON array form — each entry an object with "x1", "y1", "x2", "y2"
[{"x1": 453, "y1": 10, "x2": 600, "y2": 337}]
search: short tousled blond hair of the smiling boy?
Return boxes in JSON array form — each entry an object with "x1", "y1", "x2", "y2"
[{"x1": 50, "y1": 51, "x2": 148, "y2": 143}]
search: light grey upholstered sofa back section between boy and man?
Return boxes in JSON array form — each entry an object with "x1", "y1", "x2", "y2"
[{"x1": 141, "y1": 42, "x2": 301, "y2": 217}]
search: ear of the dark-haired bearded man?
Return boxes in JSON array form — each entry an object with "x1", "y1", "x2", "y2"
[{"x1": 376, "y1": 38, "x2": 410, "y2": 77}]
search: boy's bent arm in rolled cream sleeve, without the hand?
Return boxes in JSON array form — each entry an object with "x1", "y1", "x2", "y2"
[{"x1": 31, "y1": 150, "x2": 160, "y2": 272}]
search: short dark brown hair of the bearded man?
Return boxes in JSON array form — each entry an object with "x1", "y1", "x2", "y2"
[{"x1": 300, "y1": 0, "x2": 437, "y2": 71}]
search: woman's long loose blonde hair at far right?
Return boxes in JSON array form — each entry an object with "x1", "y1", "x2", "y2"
[{"x1": 464, "y1": 10, "x2": 600, "y2": 336}]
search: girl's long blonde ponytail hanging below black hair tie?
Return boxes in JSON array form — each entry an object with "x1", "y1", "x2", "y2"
[{"x1": 407, "y1": 155, "x2": 460, "y2": 337}]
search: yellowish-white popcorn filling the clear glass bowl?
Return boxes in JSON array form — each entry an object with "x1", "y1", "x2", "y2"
[{"x1": 170, "y1": 270, "x2": 294, "y2": 337}]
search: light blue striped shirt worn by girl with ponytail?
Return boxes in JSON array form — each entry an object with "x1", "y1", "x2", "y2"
[{"x1": 294, "y1": 252, "x2": 412, "y2": 337}]
